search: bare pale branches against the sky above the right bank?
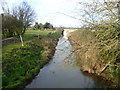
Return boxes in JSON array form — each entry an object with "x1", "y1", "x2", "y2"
[{"x1": 75, "y1": 0, "x2": 120, "y2": 26}]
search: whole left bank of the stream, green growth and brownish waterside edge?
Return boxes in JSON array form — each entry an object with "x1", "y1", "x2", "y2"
[{"x1": 2, "y1": 31, "x2": 61, "y2": 88}]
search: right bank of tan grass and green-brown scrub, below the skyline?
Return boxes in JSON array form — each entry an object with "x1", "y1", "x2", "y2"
[{"x1": 69, "y1": 26, "x2": 120, "y2": 87}]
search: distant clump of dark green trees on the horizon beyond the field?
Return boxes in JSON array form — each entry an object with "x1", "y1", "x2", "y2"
[{"x1": 34, "y1": 22, "x2": 54, "y2": 30}]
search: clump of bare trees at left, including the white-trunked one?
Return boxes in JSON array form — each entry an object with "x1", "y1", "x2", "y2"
[{"x1": 2, "y1": 2, "x2": 36, "y2": 46}]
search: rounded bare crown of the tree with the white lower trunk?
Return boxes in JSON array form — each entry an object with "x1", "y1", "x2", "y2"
[{"x1": 12, "y1": 2, "x2": 36, "y2": 35}]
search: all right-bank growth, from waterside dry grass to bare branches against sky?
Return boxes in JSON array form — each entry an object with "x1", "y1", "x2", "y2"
[{"x1": 69, "y1": 0, "x2": 120, "y2": 87}]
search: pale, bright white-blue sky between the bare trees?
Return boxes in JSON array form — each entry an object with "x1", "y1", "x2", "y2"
[{"x1": 0, "y1": 0, "x2": 88, "y2": 27}]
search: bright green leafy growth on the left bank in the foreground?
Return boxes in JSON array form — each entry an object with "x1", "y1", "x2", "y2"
[{"x1": 2, "y1": 41, "x2": 43, "y2": 88}]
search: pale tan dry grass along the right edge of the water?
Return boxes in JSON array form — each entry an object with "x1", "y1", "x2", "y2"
[{"x1": 69, "y1": 30, "x2": 101, "y2": 73}]
